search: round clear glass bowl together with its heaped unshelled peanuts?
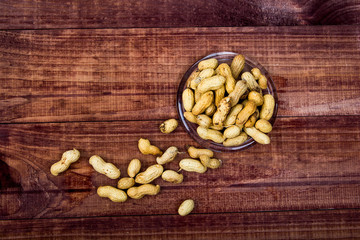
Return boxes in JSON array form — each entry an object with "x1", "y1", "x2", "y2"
[{"x1": 177, "y1": 52, "x2": 278, "y2": 152}]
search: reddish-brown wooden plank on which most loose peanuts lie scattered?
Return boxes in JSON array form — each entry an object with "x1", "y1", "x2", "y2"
[{"x1": 0, "y1": 116, "x2": 360, "y2": 219}]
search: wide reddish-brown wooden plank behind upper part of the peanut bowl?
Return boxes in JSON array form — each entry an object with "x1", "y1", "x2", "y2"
[{"x1": 0, "y1": 26, "x2": 360, "y2": 122}]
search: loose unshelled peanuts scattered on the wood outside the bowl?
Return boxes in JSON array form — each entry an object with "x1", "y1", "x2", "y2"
[{"x1": 50, "y1": 119, "x2": 221, "y2": 216}]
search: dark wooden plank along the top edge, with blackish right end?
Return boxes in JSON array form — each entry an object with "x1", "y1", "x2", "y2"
[{"x1": 0, "y1": 0, "x2": 360, "y2": 29}]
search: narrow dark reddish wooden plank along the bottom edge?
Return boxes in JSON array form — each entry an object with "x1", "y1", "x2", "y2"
[{"x1": 0, "y1": 209, "x2": 360, "y2": 240}]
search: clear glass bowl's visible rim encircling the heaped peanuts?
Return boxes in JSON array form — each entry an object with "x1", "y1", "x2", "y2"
[{"x1": 176, "y1": 51, "x2": 278, "y2": 152}]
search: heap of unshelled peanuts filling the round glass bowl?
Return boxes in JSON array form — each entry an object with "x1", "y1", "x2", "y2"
[{"x1": 182, "y1": 54, "x2": 275, "y2": 147}]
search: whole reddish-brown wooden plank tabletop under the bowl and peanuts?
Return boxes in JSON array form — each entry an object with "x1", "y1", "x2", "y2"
[{"x1": 0, "y1": 0, "x2": 360, "y2": 239}]
